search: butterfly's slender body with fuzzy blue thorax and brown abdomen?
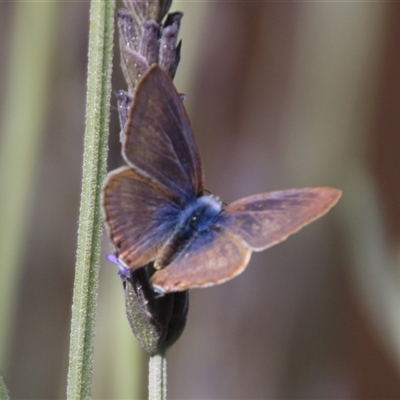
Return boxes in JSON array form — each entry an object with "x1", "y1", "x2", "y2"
[{"x1": 155, "y1": 195, "x2": 221, "y2": 269}]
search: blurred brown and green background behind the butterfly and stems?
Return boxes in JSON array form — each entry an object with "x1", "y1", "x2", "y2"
[{"x1": 0, "y1": 1, "x2": 400, "y2": 399}]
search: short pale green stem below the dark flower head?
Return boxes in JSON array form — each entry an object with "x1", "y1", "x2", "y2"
[{"x1": 149, "y1": 353, "x2": 167, "y2": 400}]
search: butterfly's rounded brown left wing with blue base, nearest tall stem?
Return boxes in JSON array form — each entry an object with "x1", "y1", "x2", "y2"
[{"x1": 102, "y1": 167, "x2": 181, "y2": 269}]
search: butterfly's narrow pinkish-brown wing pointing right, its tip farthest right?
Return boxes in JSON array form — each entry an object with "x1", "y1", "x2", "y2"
[{"x1": 221, "y1": 187, "x2": 341, "y2": 251}]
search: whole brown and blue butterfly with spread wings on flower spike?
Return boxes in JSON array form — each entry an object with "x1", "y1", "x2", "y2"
[{"x1": 102, "y1": 65, "x2": 341, "y2": 294}]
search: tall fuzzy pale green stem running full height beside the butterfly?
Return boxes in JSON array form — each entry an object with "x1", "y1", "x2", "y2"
[{"x1": 67, "y1": 0, "x2": 115, "y2": 399}]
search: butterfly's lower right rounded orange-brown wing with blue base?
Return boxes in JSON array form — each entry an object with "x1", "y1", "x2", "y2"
[{"x1": 151, "y1": 226, "x2": 251, "y2": 293}]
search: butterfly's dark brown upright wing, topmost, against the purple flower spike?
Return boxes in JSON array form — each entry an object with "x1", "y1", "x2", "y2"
[{"x1": 123, "y1": 65, "x2": 203, "y2": 202}]
